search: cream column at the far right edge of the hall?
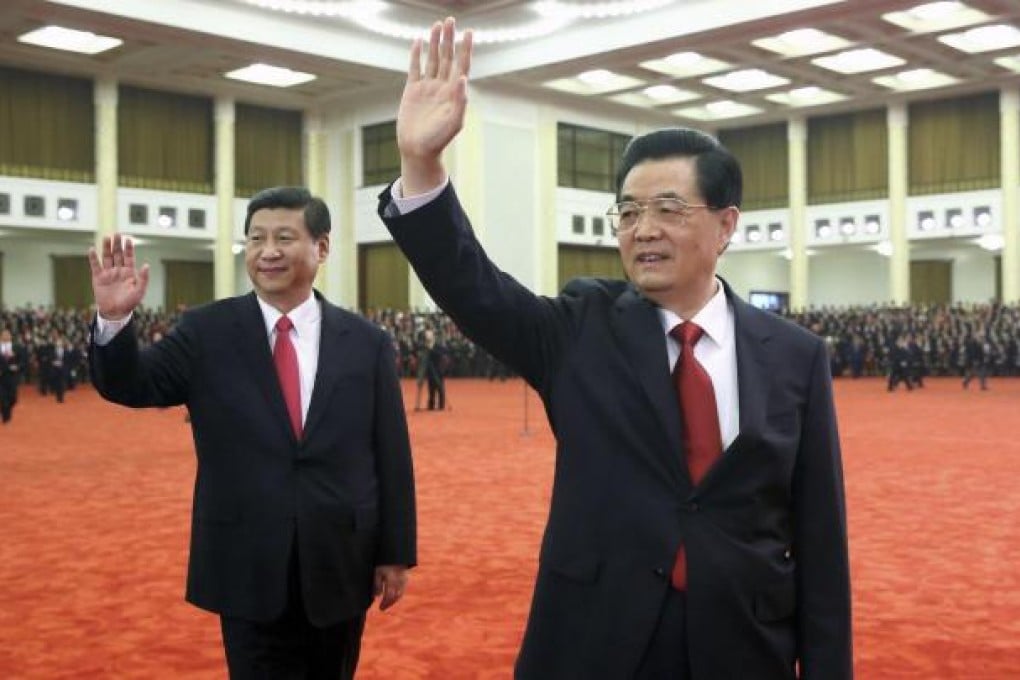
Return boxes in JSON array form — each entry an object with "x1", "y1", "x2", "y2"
[{"x1": 999, "y1": 87, "x2": 1020, "y2": 304}]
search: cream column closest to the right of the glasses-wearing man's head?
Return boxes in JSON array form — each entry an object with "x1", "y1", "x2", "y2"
[{"x1": 786, "y1": 118, "x2": 808, "y2": 310}]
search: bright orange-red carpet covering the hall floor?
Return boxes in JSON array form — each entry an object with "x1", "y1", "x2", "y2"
[{"x1": 0, "y1": 379, "x2": 1020, "y2": 680}]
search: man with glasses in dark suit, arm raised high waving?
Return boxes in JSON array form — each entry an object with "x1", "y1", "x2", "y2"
[{"x1": 379, "y1": 19, "x2": 853, "y2": 680}]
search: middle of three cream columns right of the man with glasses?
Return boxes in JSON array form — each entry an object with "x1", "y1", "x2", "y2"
[{"x1": 886, "y1": 104, "x2": 910, "y2": 305}]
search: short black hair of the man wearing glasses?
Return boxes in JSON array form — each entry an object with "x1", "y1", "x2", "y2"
[{"x1": 616, "y1": 127, "x2": 744, "y2": 208}]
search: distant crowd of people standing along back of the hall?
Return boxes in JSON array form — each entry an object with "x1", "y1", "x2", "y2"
[{"x1": 0, "y1": 303, "x2": 1020, "y2": 420}]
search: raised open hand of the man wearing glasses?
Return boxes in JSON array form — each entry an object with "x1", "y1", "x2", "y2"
[{"x1": 397, "y1": 17, "x2": 472, "y2": 196}]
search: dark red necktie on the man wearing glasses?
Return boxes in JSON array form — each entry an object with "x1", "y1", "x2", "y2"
[{"x1": 669, "y1": 321, "x2": 722, "y2": 590}]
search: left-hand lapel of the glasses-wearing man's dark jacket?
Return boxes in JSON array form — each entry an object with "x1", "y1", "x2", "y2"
[{"x1": 614, "y1": 287, "x2": 691, "y2": 485}]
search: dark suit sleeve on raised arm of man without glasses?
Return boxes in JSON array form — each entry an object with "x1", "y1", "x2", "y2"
[{"x1": 89, "y1": 314, "x2": 196, "y2": 408}]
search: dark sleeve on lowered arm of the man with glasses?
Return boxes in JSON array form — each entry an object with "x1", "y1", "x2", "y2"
[{"x1": 794, "y1": 343, "x2": 853, "y2": 680}]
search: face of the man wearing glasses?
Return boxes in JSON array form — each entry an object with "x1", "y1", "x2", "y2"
[{"x1": 619, "y1": 157, "x2": 740, "y2": 319}]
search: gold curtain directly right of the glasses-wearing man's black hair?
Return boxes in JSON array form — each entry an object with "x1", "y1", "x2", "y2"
[{"x1": 719, "y1": 122, "x2": 789, "y2": 210}]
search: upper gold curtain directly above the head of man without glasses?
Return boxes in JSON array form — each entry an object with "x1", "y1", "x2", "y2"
[{"x1": 234, "y1": 104, "x2": 304, "y2": 198}]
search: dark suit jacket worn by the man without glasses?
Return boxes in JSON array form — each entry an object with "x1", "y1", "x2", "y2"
[{"x1": 90, "y1": 294, "x2": 416, "y2": 625}]
